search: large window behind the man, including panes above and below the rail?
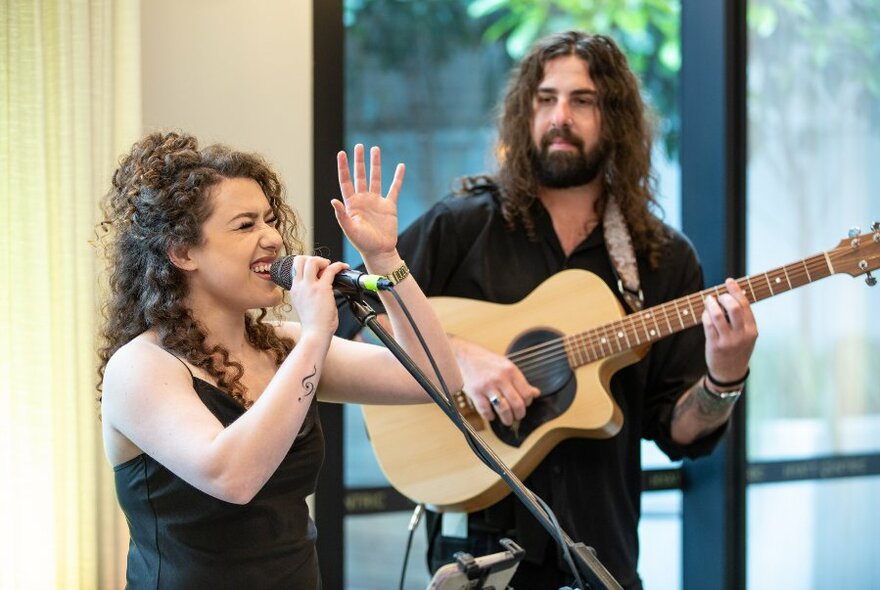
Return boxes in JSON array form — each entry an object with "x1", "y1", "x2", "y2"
[{"x1": 344, "y1": 0, "x2": 681, "y2": 590}]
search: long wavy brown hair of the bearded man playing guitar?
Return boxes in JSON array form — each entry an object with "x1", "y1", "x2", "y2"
[{"x1": 470, "y1": 31, "x2": 667, "y2": 267}]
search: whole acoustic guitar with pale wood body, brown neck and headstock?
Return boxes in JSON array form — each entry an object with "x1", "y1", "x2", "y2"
[{"x1": 363, "y1": 223, "x2": 880, "y2": 512}]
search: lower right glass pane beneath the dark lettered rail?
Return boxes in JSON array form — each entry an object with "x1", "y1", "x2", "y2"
[{"x1": 747, "y1": 477, "x2": 880, "y2": 590}]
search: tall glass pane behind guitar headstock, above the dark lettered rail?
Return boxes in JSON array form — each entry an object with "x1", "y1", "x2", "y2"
[{"x1": 747, "y1": 0, "x2": 880, "y2": 460}]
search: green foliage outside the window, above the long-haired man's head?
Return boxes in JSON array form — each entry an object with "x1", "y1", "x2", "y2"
[{"x1": 345, "y1": 0, "x2": 681, "y2": 158}]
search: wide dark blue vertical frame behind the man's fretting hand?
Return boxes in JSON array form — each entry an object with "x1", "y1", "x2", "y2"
[{"x1": 681, "y1": 0, "x2": 746, "y2": 590}]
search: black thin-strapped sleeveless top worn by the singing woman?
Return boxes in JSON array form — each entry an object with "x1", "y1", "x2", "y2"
[{"x1": 114, "y1": 377, "x2": 324, "y2": 590}]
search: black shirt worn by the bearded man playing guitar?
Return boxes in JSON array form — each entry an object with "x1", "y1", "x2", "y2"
[{"x1": 342, "y1": 193, "x2": 723, "y2": 588}]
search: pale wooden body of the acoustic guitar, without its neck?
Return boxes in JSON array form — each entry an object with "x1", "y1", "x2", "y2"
[{"x1": 363, "y1": 270, "x2": 647, "y2": 512}]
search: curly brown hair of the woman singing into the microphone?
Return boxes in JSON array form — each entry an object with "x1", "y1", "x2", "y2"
[{"x1": 97, "y1": 133, "x2": 303, "y2": 407}]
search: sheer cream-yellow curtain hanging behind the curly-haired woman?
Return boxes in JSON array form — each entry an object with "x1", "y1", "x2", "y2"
[{"x1": 0, "y1": 0, "x2": 141, "y2": 589}]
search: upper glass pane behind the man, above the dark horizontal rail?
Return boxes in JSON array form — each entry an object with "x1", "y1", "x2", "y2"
[{"x1": 344, "y1": 0, "x2": 681, "y2": 487}]
